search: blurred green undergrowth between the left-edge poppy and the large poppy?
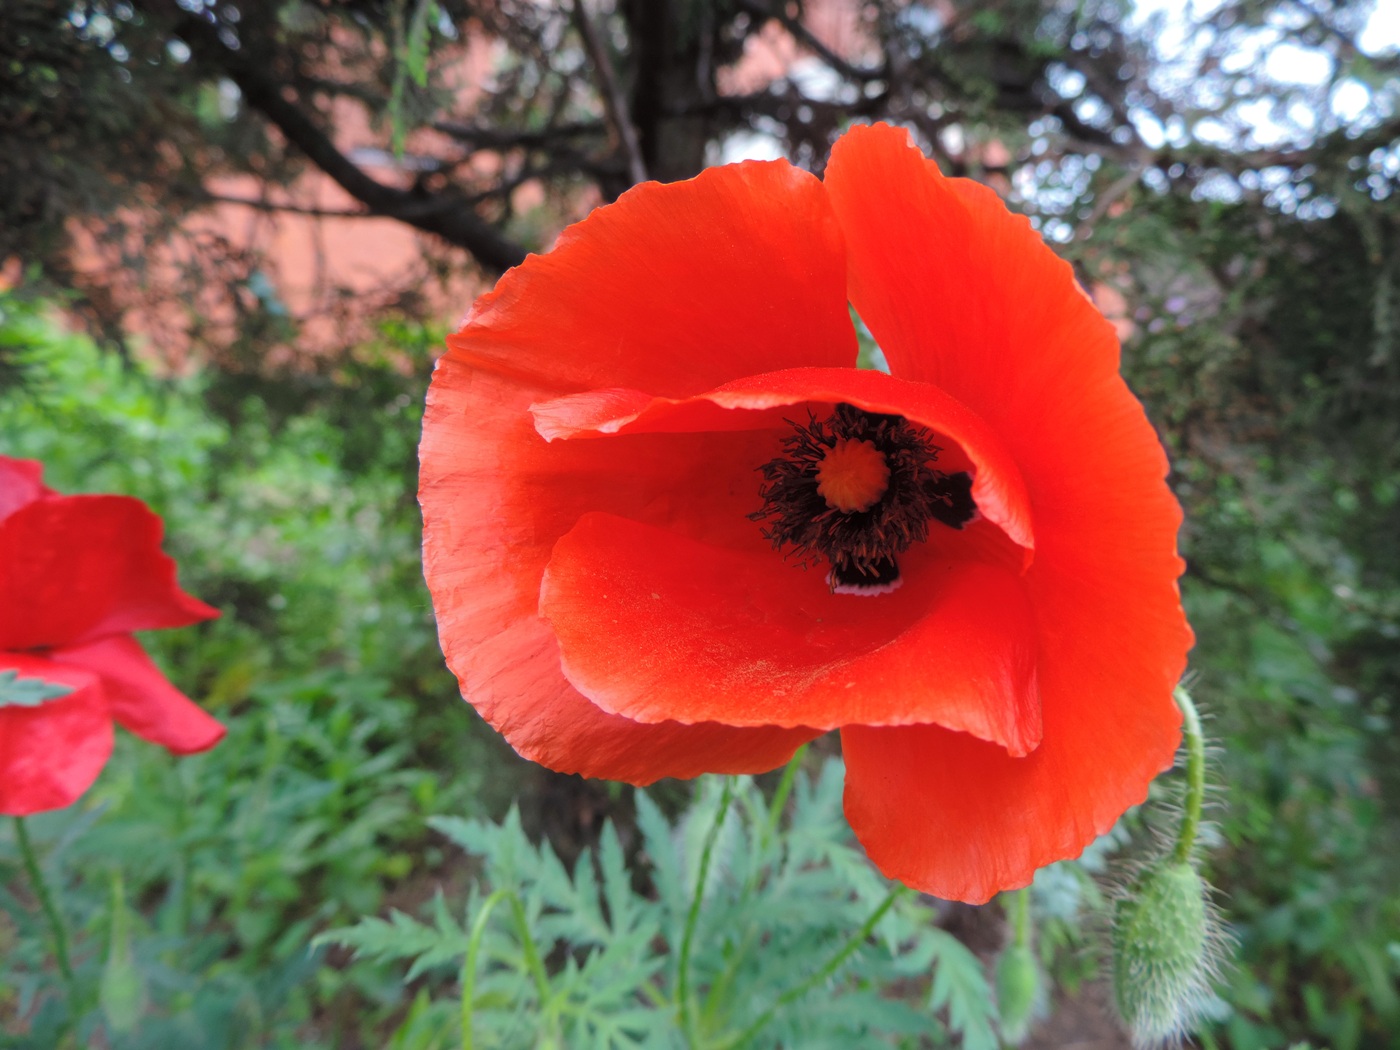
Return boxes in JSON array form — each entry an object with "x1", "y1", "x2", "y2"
[{"x1": 0, "y1": 297, "x2": 511, "y2": 1050}]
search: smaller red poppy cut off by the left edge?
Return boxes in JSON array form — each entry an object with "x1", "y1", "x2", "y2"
[{"x1": 0, "y1": 456, "x2": 224, "y2": 816}]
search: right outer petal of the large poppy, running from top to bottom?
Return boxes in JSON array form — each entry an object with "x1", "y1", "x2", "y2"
[{"x1": 826, "y1": 126, "x2": 1191, "y2": 900}]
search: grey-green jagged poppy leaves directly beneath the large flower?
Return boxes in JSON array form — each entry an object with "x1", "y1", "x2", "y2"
[{"x1": 328, "y1": 760, "x2": 998, "y2": 1050}]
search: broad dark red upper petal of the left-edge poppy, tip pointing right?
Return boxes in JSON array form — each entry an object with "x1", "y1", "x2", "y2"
[{"x1": 0, "y1": 496, "x2": 218, "y2": 650}]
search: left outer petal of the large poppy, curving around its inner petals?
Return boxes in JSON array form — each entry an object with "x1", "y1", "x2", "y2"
[{"x1": 419, "y1": 162, "x2": 855, "y2": 783}]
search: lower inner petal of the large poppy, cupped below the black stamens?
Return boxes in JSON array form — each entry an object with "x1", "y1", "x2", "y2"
[{"x1": 540, "y1": 514, "x2": 1040, "y2": 755}]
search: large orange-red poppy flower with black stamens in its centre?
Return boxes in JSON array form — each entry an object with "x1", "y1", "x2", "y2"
[{"x1": 419, "y1": 125, "x2": 1191, "y2": 902}]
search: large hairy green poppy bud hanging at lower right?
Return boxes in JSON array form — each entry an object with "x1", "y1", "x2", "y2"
[{"x1": 1113, "y1": 860, "x2": 1215, "y2": 1046}]
